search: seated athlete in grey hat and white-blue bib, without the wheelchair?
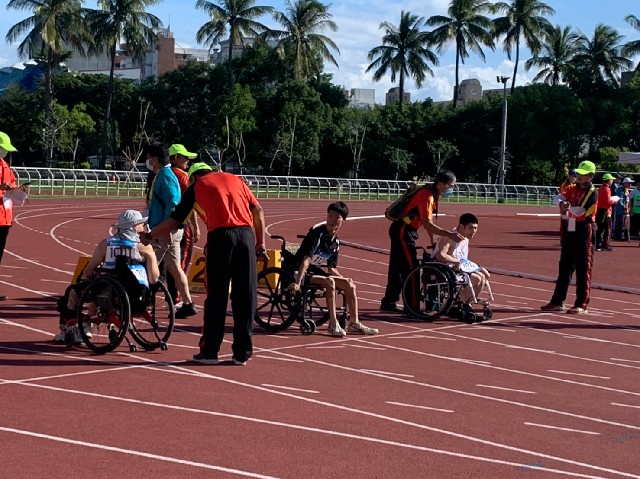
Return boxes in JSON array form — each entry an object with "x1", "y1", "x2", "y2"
[{"x1": 54, "y1": 210, "x2": 160, "y2": 342}]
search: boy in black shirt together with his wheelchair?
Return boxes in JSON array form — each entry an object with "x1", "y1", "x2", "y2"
[{"x1": 256, "y1": 202, "x2": 378, "y2": 337}]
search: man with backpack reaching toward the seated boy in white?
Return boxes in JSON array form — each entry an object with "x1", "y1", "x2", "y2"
[{"x1": 380, "y1": 170, "x2": 463, "y2": 317}]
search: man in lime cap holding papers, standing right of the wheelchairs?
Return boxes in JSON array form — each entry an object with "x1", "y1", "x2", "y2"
[{"x1": 540, "y1": 161, "x2": 598, "y2": 314}]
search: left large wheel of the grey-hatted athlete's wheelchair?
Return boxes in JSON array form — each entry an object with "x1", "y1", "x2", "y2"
[{"x1": 77, "y1": 276, "x2": 131, "y2": 354}]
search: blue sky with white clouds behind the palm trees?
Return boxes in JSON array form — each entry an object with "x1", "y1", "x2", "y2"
[{"x1": 0, "y1": 0, "x2": 640, "y2": 103}]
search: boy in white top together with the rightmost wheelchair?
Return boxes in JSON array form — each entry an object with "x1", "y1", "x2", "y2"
[{"x1": 403, "y1": 213, "x2": 493, "y2": 324}]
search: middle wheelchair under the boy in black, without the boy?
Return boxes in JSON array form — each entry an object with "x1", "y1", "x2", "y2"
[{"x1": 255, "y1": 235, "x2": 349, "y2": 334}]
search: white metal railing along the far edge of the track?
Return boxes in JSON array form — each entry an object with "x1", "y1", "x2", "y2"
[{"x1": 12, "y1": 166, "x2": 558, "y2": 205}]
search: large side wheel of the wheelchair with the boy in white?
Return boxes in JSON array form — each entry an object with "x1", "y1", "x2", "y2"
[{"x1": 402, "y1": 263, "x2": 456, "y2": 321}]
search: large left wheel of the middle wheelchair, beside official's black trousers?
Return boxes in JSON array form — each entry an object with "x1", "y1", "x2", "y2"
[{"x1": 254, "y1": 267, "x2": 303, "y2": 333}]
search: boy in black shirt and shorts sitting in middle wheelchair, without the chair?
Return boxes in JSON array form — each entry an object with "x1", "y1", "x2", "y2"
[{"x1": 288, "y1": 201, "x2": 378, "y2": 337}]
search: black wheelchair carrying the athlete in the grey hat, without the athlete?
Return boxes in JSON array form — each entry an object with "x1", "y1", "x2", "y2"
[{"x1": 58, "y1": 247, "x2": 175, "y2": 354}]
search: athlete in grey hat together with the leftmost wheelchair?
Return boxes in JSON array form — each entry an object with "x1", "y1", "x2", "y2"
[{"x1": 54, "y1": 210, "x2": 175, "y2": 354}]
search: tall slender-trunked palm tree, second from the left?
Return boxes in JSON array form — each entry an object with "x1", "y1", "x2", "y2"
[{"x1": 86, "y1": 0, "x2": 162, "y2": 168}]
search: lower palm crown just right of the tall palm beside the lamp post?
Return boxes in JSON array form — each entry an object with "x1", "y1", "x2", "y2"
[{"x1": 524, "y1": 25, "x2": 578, "y2": 85}]
